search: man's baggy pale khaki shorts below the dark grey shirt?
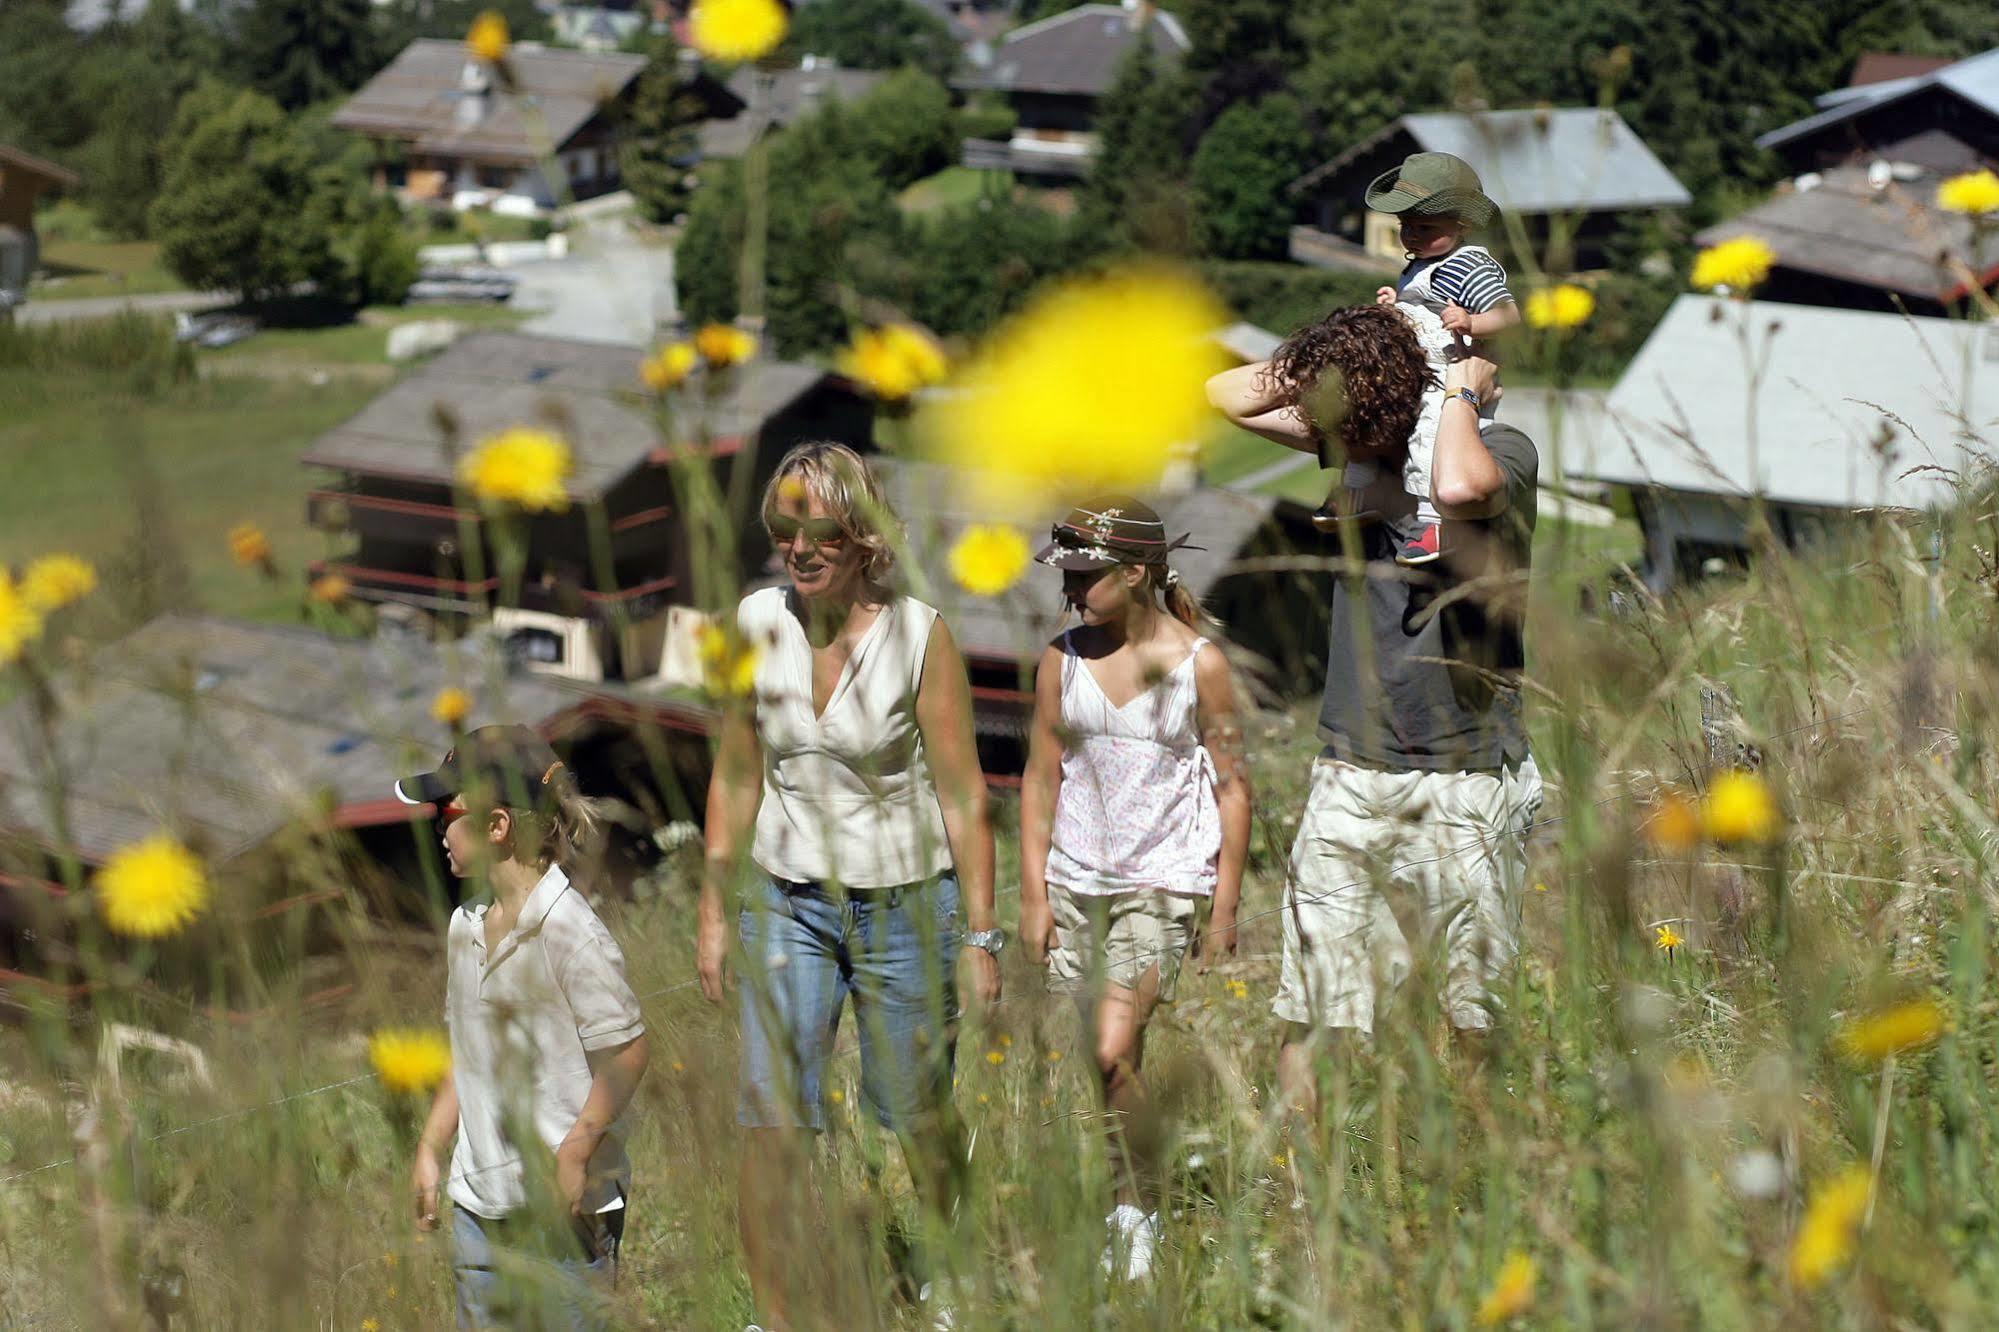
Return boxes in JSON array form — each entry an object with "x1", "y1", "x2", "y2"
[{"x1": 1271, "y1": 758, "x2": 1539, "y2": 1032}]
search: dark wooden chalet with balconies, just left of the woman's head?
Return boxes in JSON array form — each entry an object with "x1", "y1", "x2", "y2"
[{"x1": 304, "y1": 332, "x2": 874, "y2": 680}]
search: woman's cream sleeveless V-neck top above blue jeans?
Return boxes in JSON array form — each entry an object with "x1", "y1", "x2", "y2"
[{"x1": 736, "y1": 588, "x2": 952, "y2": 888}]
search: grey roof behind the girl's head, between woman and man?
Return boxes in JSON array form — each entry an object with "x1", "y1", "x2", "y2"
[{"x1": 876, "y1": 460, "x2": 1277, "y2": 662}]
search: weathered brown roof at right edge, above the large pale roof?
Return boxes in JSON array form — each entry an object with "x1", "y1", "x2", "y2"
[{"x1": 1695, "y1": 166, "x2": 1999, "y2": 300}]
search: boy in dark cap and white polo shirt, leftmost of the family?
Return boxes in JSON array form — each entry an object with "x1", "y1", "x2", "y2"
[{"x1": 396, "y1": 724, "x2": 646, "y2": 1328}]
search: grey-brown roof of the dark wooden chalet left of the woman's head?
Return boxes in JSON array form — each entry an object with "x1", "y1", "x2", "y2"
[{"x1": 304, "y1": 332, "x2": 830, "y2": 502}]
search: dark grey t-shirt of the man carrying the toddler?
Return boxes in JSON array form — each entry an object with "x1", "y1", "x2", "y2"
[{"x1": 1319, "y1": 426, "x2": 1539, "y2": 772}]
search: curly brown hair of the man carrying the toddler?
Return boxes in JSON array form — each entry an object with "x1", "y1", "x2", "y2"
[{"x1": 1267, "y1": 306, "x2": 1437, "y2": 458}]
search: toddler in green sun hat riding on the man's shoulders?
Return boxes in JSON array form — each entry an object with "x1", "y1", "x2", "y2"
[{"x1": 1313, "y1": 152, "x2": 1519, "y2": 564}]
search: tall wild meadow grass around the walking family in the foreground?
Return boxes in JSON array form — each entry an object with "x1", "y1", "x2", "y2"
[{"x1": 0, "y1": 472, "x2": 1999, "y2": 1328}]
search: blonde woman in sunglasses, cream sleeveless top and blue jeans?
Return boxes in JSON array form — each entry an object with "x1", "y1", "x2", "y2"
[{"x1": 698, "y1": 444, "x2": 1003, "y2": 1328}]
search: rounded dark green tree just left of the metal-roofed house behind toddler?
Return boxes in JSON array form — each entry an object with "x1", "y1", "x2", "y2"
[{"x1": 1191, "y1": 92, "x2": 1313, "y2": 258}]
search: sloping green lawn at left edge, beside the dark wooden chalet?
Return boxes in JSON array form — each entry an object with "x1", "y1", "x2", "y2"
[{"x1": 0, "y1": 370, "x2": 378, "y2": 630}]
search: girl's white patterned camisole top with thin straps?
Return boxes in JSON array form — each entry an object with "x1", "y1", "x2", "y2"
[{"x1": 1047, "y1": 634, "x2": 1221, "y2": 896}]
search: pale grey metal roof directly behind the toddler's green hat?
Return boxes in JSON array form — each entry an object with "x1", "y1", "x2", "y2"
[{"x1": 1291, "y1": 106, "x2": 1693, "y2": 214}]
